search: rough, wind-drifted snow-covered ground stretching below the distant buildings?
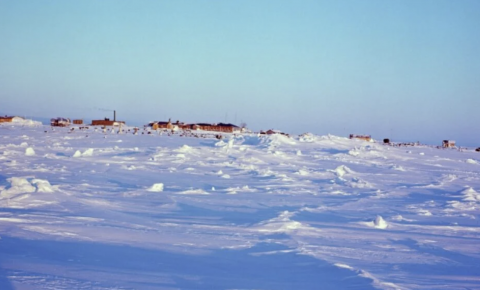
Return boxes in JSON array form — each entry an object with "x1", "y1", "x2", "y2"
[{"x1": 0, "y1": 124, "x2": 480, "y2": 290}]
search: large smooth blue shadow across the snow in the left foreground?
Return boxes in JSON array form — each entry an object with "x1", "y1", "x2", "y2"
[{"x1": 0, "y1": 237, "x2": 374, "y2": 290}]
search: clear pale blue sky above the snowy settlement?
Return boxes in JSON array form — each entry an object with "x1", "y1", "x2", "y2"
[{"x1": 0, "y1": 0, "x2": 480, "y2": 146}]
